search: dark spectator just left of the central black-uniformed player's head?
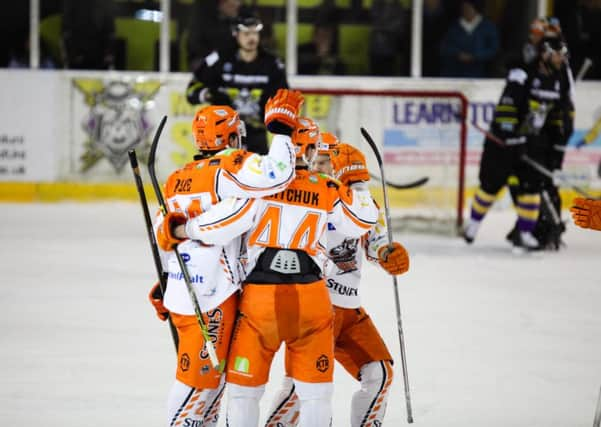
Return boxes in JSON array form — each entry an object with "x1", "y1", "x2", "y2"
[{"x1": 188, "y1": 0, "x2": 242, "y2": 70}]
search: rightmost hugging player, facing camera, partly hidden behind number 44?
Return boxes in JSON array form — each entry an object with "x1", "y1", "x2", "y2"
[{"x1": 266, "y1": 140, "x2": 409, "y2": 427}]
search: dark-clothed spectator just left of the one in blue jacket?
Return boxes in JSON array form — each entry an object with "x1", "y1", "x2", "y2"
[{"x1": 369, "y1": 0, "x2": 410, "y2": 76}]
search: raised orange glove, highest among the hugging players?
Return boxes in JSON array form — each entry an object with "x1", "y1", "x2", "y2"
[{"x1": 265, "y1": 89, "x2": 305, "y2": 136}]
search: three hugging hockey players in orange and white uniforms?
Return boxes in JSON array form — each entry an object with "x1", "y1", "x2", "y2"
[{"x1": 150, "y1": 89, "x2": 409, "y2": 427}]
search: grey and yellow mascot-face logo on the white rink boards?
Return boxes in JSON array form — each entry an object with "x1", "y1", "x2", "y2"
[{"x1": 73, "y1": 79, "x2": 161, "y2": 173}]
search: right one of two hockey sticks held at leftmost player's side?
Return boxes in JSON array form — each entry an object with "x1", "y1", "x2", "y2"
[{"x1": 148, "y1": 116, "x2": 219, "y2": 369}]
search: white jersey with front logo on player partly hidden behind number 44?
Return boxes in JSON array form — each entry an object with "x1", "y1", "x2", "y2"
[{"x1": 325, "y1": 202, "x2": 388, "y2": 308}]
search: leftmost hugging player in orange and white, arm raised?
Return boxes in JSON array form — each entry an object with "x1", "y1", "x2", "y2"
[{"x1": 150, "y1": 89, "x2": 303, "y2": 426}]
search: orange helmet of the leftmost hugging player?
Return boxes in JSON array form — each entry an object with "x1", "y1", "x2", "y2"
[{"x1": 192, "y1": 105, "x2": 245, "y2": 151}]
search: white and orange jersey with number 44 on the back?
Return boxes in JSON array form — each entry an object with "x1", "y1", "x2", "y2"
[{"x1": 186, "y1": 170, "x2": 378, "y2": 273}]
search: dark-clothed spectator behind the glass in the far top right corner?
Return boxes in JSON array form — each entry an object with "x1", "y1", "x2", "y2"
[{"x1": 556, "y1": 0, "x2": 601, "y2": 79}]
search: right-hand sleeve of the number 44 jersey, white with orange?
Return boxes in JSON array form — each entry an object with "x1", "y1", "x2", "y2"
[{"x1": 328, "y1": 181, "x2": 378, "y2": 237}]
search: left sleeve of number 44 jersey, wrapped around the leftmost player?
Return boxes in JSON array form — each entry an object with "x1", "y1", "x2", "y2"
[{"x1": 186, "y1": 197, "x2": 257, "y2": 245}]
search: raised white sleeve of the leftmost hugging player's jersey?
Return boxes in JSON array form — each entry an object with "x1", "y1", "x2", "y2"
[{"x1": 216, "y1": 135, "x2": 296, "y2": 199}]
